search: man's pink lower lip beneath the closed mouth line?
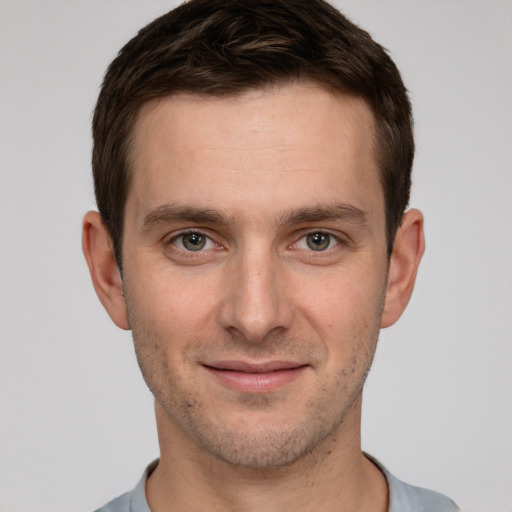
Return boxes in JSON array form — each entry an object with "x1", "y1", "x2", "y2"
[{"x1": 205, "y1": 366, "x2": 307, "y2": 393}]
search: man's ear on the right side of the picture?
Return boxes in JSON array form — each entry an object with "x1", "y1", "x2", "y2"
[{"x1": 381, "y1": 210, "x2": 425, "y2": 327}]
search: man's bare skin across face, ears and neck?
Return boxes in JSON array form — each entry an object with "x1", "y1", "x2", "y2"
[{"x1": 83, "y1": 84, "x2": 424, "y2": 512}]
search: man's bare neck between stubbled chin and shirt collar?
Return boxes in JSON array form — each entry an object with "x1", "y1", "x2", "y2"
[{"x1": 146, "y1": 399, "x2": 388, "y2": 512}]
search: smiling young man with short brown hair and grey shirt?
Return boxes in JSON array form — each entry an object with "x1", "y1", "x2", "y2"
[{"x1": 83, "y1": 0, "x2": 458, "y2": 512}]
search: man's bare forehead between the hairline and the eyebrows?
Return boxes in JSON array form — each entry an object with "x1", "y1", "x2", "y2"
[{"x1": 127, "y1": 85, "x2": 381, "y2": 224}]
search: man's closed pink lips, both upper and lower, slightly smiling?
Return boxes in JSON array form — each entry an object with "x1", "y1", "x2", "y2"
[{"x1": 203, "y1": 360, "x2": 308, "y2": 393}]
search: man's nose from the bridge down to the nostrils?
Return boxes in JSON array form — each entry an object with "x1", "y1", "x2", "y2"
[{"x1": 220, "y1": 247, "x2": 293, "y2": 343}]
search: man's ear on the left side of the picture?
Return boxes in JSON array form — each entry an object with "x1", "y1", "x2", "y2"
[{"x1": 82, "y1": 212, "x2": 130, "y2": 329}]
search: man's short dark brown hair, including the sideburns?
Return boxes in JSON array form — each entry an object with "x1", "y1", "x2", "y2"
[{"x1": 92, "y1": 0, "x2": 414, "y2": 268}]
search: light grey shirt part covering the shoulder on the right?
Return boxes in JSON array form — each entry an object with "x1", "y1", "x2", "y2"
[{"x1": 365, "y1": 454, "x2": 460, "y2": 512}]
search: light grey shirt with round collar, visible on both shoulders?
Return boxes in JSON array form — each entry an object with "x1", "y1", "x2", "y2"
[{"x1": 96, "y1": 455, "x2": 460, "y2": 512}]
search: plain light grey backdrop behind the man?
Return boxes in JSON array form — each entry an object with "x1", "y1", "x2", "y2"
[{"x1": 0, "y1": 0, "x2": 512, "y2": 512}]
